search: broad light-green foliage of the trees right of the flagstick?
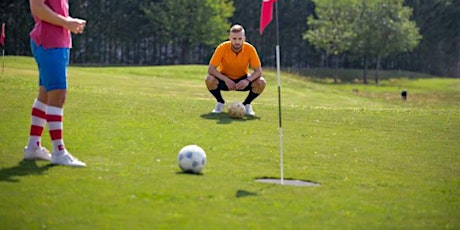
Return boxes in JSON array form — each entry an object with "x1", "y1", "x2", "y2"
[{"x1": 304, "y1": 0, "x2": 421, "y2": 82}]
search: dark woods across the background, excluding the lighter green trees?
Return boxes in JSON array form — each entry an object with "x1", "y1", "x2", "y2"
[{"x1": 0, "y1": 0, "x2": 460, "y2": 77}]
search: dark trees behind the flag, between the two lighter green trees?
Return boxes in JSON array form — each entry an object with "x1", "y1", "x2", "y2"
[{"x1": 231, "y1": 0, "x2": 321, "y2": 70}]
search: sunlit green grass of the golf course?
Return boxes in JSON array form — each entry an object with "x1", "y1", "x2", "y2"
[{"x1": 0, "y1": 57, "x2": 460, "y2": 229}]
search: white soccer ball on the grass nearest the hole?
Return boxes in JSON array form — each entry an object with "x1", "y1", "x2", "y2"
[{"x1": 177, "y1": 145, "x2": 206, "y2": 173}]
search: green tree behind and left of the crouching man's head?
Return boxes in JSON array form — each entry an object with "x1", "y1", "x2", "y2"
[{"x1": 142, "y1": 0, "x2": 234, "y2": 63}]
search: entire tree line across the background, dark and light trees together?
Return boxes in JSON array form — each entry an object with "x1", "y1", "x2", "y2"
[{"x1": 0, "y1": 0, "x2": 460, "y2": 77}]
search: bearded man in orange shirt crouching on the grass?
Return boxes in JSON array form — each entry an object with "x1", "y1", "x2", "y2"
[{"x1": 205, "y1": 25, "x2": 266, "y2": 116}]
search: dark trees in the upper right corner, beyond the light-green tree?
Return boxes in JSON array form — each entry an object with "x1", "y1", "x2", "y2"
[{"x1": 400, "y1": 0, "x2": 460, "y2": 78}]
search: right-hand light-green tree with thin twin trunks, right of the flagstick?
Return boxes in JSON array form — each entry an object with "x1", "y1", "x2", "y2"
[{"x1": 351, "y1": 0, "x2": 421, "y2": 84}]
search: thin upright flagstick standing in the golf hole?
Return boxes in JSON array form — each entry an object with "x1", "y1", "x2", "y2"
[{"x1": 275, "y1": 1, "x2": 284, "y2": 184}]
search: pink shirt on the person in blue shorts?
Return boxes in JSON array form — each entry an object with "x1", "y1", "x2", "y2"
[{"x1": 30, "y1": 0, "x2": 72, "y2": 49}]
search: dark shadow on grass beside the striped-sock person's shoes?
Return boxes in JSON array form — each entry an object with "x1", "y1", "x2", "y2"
[{"x1": 0, "y1": 159, "x2": 54, "y2": 182}]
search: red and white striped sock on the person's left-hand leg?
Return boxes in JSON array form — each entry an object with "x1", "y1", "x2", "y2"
[{"x1": 27, "y1": 99, "x2": 47, "y2": 148}]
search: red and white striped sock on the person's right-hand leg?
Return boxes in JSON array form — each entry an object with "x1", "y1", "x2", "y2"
[{"x1": 46, "y1": 106, "x2": 65, "y2": 156}]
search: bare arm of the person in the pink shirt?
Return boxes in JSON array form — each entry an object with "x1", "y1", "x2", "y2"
[{"x1": 29, "y1": 0, "x2": 86, "y2": 34}]
